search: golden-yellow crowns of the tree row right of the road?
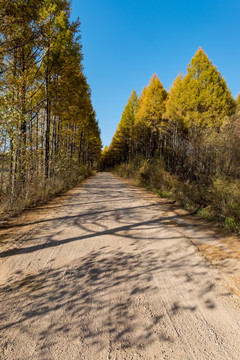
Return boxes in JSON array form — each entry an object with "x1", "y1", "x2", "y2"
[{"x1": 105, "y1": 48, "x2": 236, "y2": 167}]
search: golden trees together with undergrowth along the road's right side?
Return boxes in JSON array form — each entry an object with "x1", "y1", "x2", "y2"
[{"x1": 101, "y1": 48, "x2": 240, "y2": 231}]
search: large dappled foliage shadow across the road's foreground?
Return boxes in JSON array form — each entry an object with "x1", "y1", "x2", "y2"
[{"x1": 0, "y1": 243, "x2": 219, "y2": 359}]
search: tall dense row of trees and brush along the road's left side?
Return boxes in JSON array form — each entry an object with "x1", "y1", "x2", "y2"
[{"x1": 0, "y1": 0, "x2": 101, "y2": 212}]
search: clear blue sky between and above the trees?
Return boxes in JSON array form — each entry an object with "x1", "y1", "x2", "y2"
[{"x1": 72, "y1": 0, "x2": 240, "y2": 145}]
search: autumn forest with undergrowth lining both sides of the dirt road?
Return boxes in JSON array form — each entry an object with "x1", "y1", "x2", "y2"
[{"x1": 0, "y1": 0, "x2": 240, "y2": 231}]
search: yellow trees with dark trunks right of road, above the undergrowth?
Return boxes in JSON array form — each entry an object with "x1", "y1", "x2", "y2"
[{"x1": 103, "y1": 48, "x2": 240, "y2": 187}]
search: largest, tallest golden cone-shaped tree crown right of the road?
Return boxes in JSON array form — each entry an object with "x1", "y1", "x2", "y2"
[{"x1": 167, "y1": 48, "x2": 235, "y2": 131}]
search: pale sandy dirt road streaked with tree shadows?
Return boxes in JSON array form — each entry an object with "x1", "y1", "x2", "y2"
[{"x1": 0, "y1": 173, "x2": 240, "y2": 360}]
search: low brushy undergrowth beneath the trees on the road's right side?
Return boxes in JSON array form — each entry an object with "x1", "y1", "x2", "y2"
[{"x1": 113, "y1": 158, "x2": 240, "y2": 233}]
